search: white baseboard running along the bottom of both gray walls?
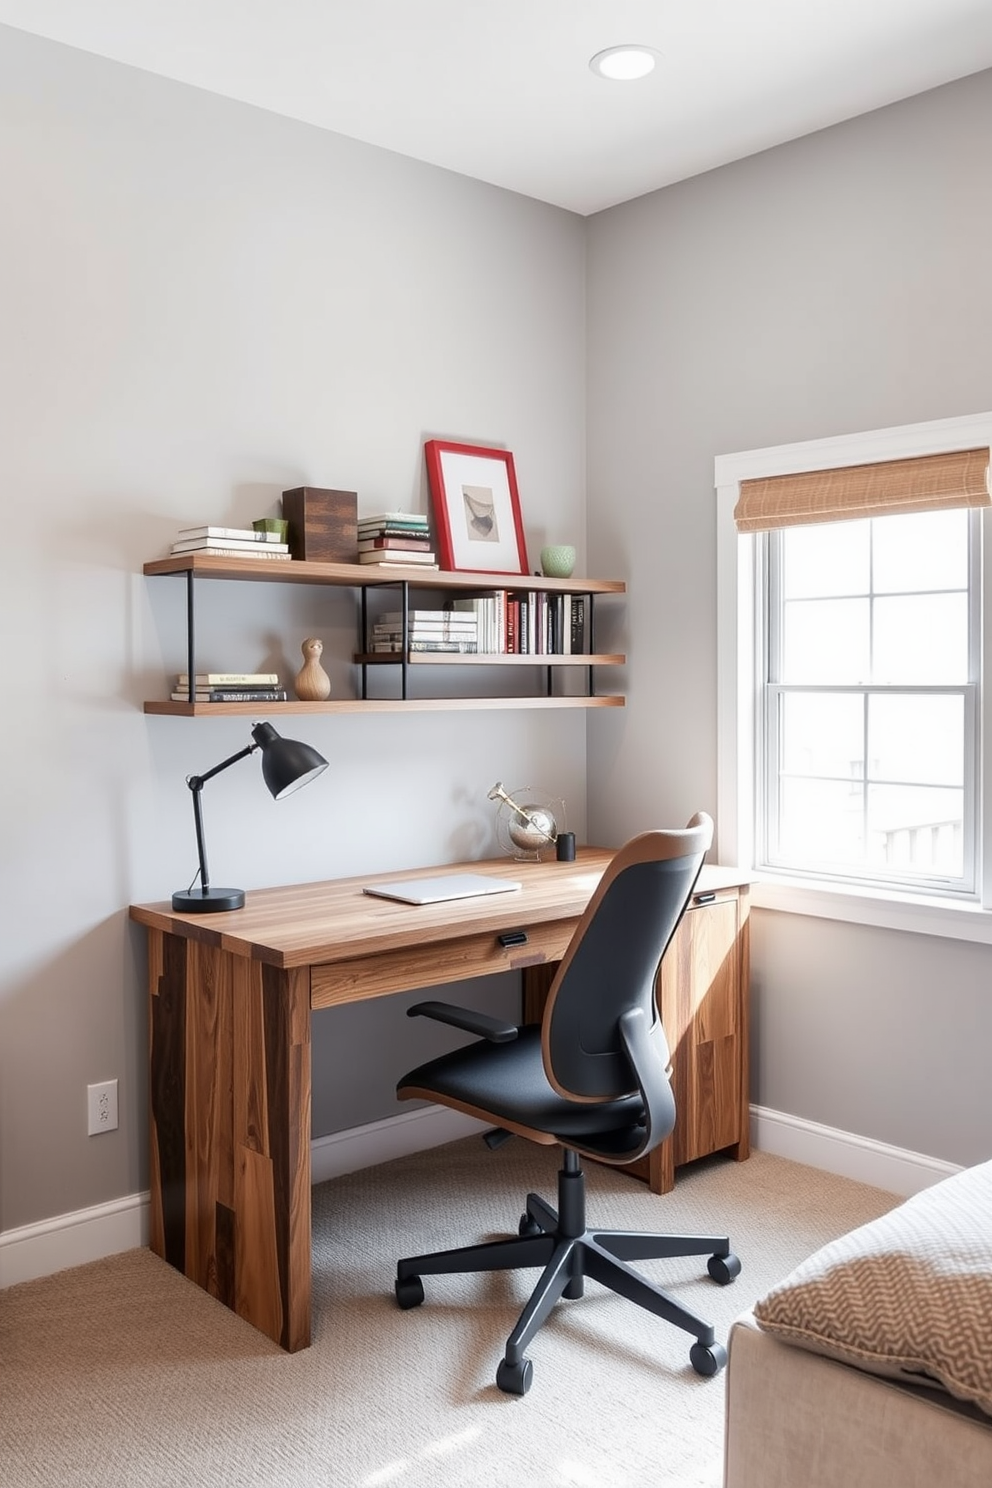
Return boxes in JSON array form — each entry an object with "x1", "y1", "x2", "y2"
[{"x1": 0, "y1": 1106, "x2": 959, "y2": 1289}]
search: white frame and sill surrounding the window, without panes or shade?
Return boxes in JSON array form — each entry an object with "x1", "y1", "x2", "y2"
[{"x1": 714, "y1": 412, "x2": 992, "y2": 945}]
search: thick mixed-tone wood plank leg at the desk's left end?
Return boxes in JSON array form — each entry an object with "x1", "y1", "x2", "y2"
[{"x1": 149, "y1": 930, "x2": 311, "y2": 1353}]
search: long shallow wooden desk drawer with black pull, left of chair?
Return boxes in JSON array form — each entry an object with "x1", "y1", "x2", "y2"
[{"x1": 309, "y1": 918, "x2": 579, "y2": 1007}]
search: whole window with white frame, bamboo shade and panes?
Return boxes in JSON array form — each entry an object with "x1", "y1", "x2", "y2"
[{"x1": 715, "y1": 414, "x2": 992, "y2": 942}]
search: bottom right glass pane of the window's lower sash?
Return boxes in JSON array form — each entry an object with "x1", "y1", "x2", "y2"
[{"x1": 869, "y1": 786, "x2": 964, "y2": 878}]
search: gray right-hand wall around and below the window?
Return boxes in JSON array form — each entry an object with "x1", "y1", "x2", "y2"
[{"x1": 587, "y1": 73, "x2": 992, "y2": 1164}]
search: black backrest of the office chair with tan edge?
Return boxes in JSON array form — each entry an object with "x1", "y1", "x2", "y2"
[{"x1": 541, "y1": 812, "x2": 712, "y2": 1103}]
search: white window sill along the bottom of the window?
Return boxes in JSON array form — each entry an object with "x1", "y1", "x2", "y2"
[{"x1": 751, "y1": 876, "x2": 992, "y2": 945}]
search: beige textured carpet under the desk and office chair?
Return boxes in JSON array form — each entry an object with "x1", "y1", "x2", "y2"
[{"x1": 0, "y1": 1138, "x2": 897, "y2": 1488}]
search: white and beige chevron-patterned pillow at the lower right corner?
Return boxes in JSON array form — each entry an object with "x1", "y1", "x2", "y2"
[{"x1": 754, "y1": 1162, "x2": 992, "y2": 1415}]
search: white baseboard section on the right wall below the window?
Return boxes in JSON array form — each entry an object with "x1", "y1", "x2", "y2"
[{"x1": 751, "y1": 1106, "x2": 961, "y2": 1198}]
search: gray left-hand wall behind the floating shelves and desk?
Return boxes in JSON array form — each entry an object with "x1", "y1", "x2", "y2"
[{"x1": 0, "y1": 28, "x2": 586, "y2": 1231}]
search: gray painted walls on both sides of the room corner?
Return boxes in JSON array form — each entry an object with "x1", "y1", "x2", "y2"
[{"x1": 0, "y1": 28, "x2": 992, "y2": 1231}]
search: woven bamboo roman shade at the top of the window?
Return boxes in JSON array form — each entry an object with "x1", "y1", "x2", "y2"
[{"x1": 733, "y1": 449, "x2": 992, "y2": 533}]
